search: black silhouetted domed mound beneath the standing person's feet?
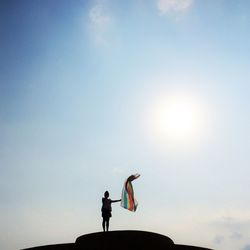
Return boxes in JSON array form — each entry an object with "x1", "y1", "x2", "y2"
[{"x1": 23, "y1": 231, "x2": 211, "y2": 250}]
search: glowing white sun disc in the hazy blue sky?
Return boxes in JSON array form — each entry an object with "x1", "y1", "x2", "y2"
[{"x1": 147, "y1": 94, "x2": 205, "y2": 145}]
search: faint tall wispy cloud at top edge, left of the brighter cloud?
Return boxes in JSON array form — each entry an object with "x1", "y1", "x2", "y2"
[{"x1": 88, "y1": 0, "x2": 112, "y2": 44}]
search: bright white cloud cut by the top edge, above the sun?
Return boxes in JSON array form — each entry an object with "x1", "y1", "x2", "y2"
[{"x1": 157, "y1": 0, "x2": 194, "y2": 15}]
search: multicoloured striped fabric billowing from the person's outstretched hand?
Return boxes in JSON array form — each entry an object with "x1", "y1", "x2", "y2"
[{"x1": 121, "y1": 174, "x2": 140, "y2": 212}]
